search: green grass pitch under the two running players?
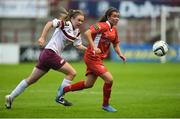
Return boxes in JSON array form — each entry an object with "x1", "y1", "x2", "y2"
[{"x1": 0, "y1": 62, "x2": 180, "y2": 118}]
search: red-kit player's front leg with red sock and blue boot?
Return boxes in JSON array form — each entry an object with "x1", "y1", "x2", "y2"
[{"x1": 100, "y1": 72, "x2": 117, "y2": 112}]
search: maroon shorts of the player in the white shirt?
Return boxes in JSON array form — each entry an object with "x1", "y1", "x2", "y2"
[{"x1": 36, "y1": 49, "x2": 66, "y2": 71}]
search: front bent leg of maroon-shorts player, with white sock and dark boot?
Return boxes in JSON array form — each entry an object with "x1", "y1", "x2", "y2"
[{"x1": 56, "y1": 62, "x2": 76, "y2": 106}]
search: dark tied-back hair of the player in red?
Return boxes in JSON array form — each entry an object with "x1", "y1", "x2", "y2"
[{"x1": 99, "y1": 7, "x2": 119, "y2": 22}]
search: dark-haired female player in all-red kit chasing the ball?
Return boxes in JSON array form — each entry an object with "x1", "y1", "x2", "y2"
[{"x1": 60, "y1": 8, "x2": 126, "y2": 112}]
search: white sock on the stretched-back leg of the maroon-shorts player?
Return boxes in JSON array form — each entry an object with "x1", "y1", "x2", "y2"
[{"x1": 10, "y1": 80, "x2": 28, "y2": 99}]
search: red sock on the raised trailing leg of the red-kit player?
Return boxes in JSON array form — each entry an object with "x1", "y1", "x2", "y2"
[{"x1": 64, "y1": 81, "x2": 85, "y2": 92}]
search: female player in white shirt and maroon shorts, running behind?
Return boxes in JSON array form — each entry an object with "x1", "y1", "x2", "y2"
[{"x1": 5, "y1": 10, "x2": 87, "y2": 109}]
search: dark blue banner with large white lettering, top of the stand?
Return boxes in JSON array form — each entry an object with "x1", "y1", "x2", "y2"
[{"x1": 69, "y1": 0, "x2": 180, "y2": 18}]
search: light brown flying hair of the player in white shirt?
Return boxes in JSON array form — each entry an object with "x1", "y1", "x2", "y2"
[{"x1": 60, "y1": 7, "x2": 84, "y2": 21}]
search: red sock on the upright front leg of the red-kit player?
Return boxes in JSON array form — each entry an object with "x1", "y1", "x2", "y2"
[{"x1": 103, "y1": 83, "x2": 112, "y2": 106}]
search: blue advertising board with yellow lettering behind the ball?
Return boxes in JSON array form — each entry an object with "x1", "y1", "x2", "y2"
[{"x1": 111, "y1": 44, "x2": 180, "y2": 62}]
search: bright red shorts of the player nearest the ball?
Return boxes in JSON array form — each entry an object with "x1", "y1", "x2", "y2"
[{"x1": 84, "y1": 56, "x2": 108, "y2": 76}]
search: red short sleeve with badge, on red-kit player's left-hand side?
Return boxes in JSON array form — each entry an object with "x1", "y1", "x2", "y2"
[{"x1": 89, "y1": 22, "x2": 109, "y2": 34}]
